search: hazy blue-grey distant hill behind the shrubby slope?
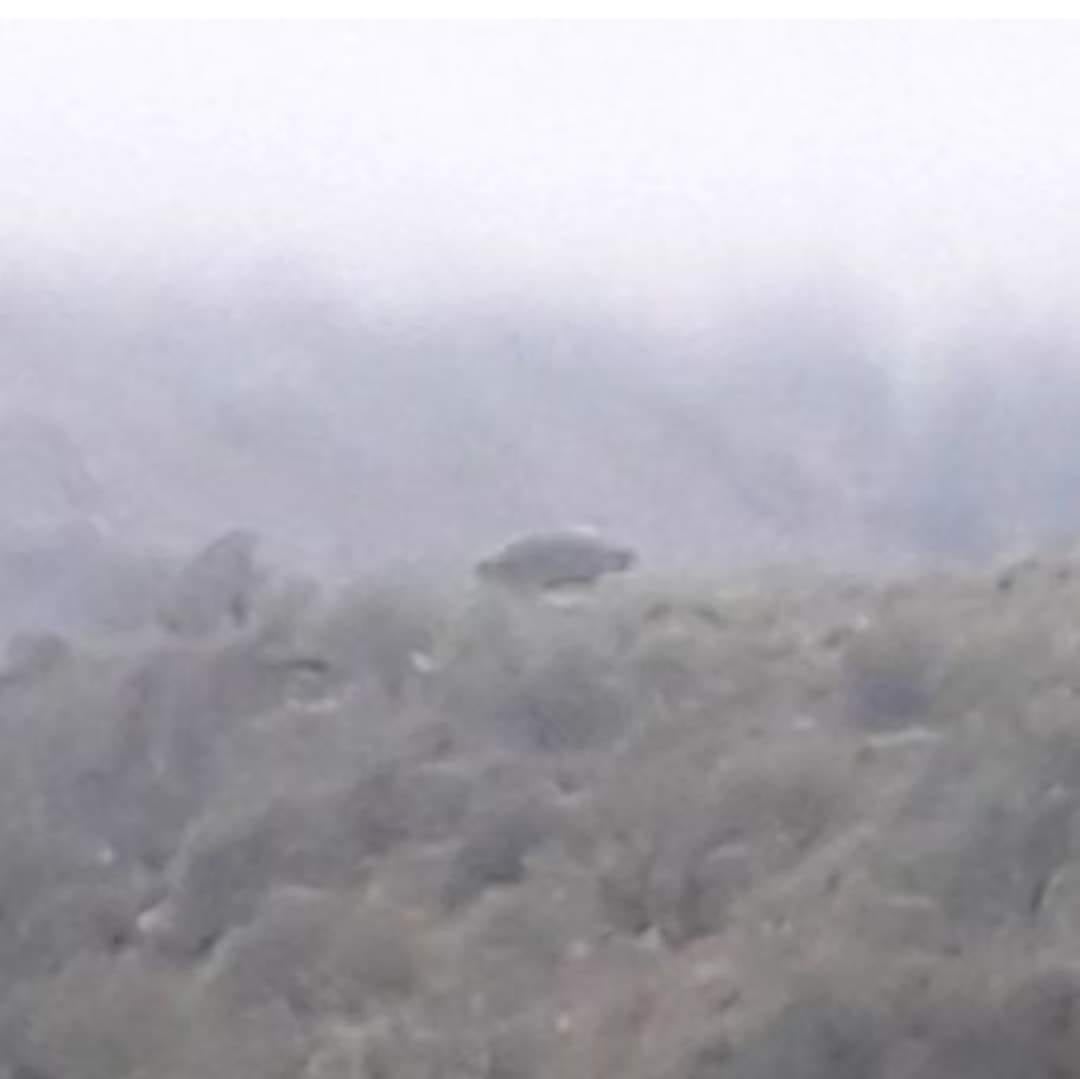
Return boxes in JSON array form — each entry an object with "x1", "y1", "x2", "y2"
[{"x1": 6, "y1": 274, "x2": 1080, "y2": 569}]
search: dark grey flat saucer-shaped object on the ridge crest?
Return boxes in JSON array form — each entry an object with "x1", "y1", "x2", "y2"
[{"x1": 476, "y1": 529, "x2": 637, "y2": 591}]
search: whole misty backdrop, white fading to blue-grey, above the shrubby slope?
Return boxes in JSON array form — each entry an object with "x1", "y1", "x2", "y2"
[{"x1": 0, "y1": 22, "x2": 1080, "y2": 617}]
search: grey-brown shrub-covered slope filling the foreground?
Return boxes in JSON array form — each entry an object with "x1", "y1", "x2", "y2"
[{"x1": 6, "y1": 544, "x2": 1080, "y2": 1079}]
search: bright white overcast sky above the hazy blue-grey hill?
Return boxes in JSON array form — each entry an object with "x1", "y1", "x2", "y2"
[{"x1": 0, "y1": 22, "x2": 1080, "y2": 316}]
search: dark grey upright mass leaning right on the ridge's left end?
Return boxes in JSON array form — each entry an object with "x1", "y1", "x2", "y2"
[{"x1": 161, "y1": 528, "x2": 258, "y2": 636}]
